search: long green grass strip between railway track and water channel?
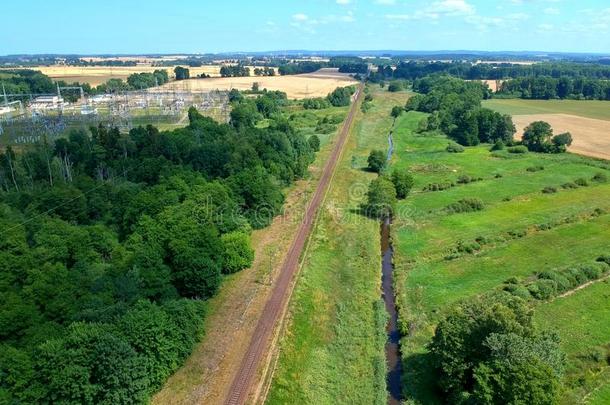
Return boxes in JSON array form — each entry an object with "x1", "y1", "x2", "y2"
[{"x1": 267, "y1": 87, "x2": 408, "y2": 404}]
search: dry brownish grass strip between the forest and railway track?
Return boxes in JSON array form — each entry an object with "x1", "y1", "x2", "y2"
[{"x1": 152, "y1": 104, "x2": 348, "y2": 405}]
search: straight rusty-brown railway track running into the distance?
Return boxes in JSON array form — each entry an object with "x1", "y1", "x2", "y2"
[{"x1": 225, "y1": 84, "x2": 364, "y2": 405}]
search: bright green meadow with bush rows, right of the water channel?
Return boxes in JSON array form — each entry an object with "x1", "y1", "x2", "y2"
[{"x1": 392, "y1": 103, "x2": 610, "y2": 403}]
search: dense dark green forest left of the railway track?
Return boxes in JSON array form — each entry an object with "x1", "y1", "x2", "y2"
[{"x1": 0, "y1": 88, "x2": 315, "y2": 404}]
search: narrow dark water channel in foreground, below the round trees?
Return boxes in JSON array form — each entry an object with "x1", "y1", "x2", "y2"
[{"x1": 381, "y1": 218, "x2": 402, "y2": 405}]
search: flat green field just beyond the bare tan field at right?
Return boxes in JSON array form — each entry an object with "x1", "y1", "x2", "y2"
[{"x1": 483, "y1": 98, "x2": 610, "y2": 120}]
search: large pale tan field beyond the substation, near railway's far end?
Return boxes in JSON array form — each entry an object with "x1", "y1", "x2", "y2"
[{"x1": 155, "y1": 71, "x2": 357, "y2": 99}]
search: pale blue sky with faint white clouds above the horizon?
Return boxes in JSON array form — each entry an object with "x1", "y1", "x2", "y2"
[{"x1": 0, "y1": 0, "x2": 610, "y2": 55}]
